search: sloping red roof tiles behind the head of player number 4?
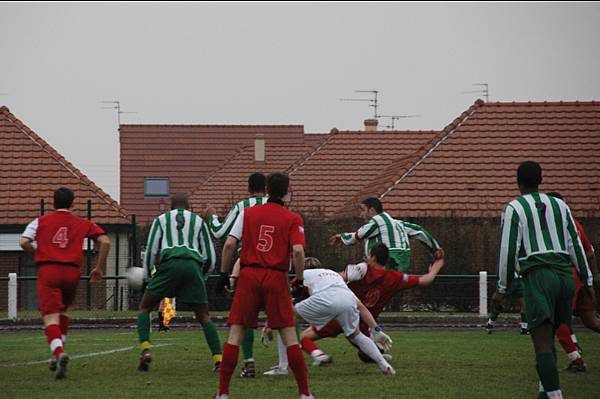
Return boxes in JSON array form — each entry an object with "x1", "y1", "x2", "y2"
[{"x1": 0, "y1": 107, "x2": 129, "y2": 225}]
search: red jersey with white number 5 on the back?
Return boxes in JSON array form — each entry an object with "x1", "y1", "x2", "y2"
[{"x1": 240, "y1": 202, "x2": 306, "y2": 272}]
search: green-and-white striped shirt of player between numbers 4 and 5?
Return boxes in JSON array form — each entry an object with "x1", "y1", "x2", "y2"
[{"x1": 144, "y1": 209, "x2": 217, "y2": 278}]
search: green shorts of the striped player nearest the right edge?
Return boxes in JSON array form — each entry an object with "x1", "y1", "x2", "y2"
[{"x1": 523, "y1": 266, "x2": 575, "y2": 330}]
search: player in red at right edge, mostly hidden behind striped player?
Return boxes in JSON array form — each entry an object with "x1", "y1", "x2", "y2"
[{"x1": 548, "y1": 192, "x2": 600, "y2": 373}]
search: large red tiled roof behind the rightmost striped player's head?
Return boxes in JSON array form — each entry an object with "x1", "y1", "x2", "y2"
[{"x1": 380, "y1": 101, "x2": 600, "y2": 217}]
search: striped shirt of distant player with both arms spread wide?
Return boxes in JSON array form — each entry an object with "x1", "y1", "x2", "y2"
[{"x1": 341, "y1": 212, "x2": 440, "y2": 256}]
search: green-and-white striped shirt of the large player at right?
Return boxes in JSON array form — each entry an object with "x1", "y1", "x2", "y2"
[{"x1": 498, "y1": 193, "x2": 592, "y2": 293}]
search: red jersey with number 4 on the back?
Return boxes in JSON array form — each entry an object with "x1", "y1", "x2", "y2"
[{"x1": 23, "y1": 210, "x2": 104, "y2": 267}]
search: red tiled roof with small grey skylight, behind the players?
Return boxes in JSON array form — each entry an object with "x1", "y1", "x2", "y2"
[{"x1": 120, "y1": 125, "x2": 318, "y2": 223}]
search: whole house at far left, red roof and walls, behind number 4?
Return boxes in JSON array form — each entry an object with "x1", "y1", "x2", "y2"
[{"x1": 0, "y1": 106, "x2": 132, "y2": 309}]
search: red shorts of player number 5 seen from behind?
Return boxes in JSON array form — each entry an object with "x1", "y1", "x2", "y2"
[{"x1": 227, "y1": 267, "x2": 296, "y2": 330}]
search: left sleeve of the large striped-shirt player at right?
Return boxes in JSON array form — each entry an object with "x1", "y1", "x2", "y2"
[{"x1": 496, "y1": 205, "x2": 521, "y2": 294}]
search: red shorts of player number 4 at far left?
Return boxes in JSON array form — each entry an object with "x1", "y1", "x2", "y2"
[{"x1": 38, "y1": 264, "x2": 81, "y2": 316}]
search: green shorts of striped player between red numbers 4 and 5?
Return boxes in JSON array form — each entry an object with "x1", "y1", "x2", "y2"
[{"x1": 146, "y1": 258, "x2": 208, "y2": 304}]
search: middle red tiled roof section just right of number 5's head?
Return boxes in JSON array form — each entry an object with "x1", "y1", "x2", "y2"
[{"x1": 289, "y1": 129, "x2": 437, "y2": 217}]
